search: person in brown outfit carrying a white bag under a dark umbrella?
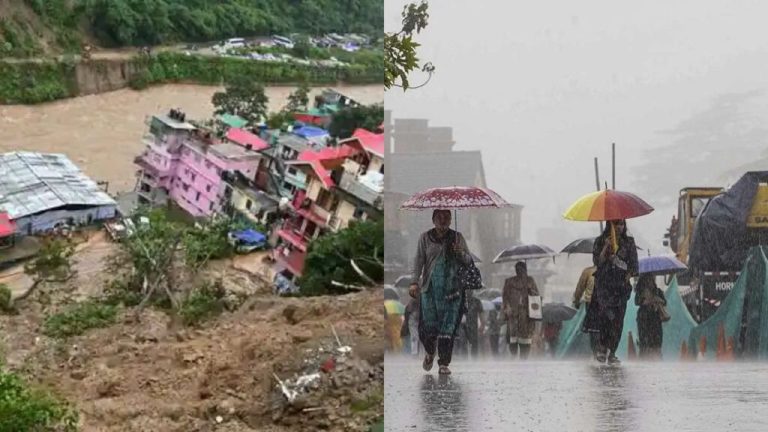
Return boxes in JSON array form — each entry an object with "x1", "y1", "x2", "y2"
[{"x1": 502, "y1": 261, "x2": 539, "y2": 359}]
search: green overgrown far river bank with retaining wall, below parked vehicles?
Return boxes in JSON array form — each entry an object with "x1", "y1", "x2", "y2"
[{"x1": 0, "y1": 52, "x2": 384, "y2": 104}]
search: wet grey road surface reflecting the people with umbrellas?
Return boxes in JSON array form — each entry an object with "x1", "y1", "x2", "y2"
[{"x1": 384, "y1": 356, "x2": 768, "y2": 432}]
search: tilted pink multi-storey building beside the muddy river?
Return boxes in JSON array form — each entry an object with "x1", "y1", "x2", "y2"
[{"x1": 135, "y1": 111, "x2": 260, "y2": 216}]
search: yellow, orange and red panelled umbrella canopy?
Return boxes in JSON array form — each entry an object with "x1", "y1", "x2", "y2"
[{"x1": 563, "y1": 189, "x2": 653, "y2": 221}]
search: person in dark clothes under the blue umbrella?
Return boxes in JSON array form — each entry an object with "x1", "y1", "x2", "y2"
[{"x1": 635, "y1": 275, "x2": 667, "y2": 359}]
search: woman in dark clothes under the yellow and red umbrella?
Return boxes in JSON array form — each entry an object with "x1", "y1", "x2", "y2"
[{"x1": 582, "y1": 220, "x2": 638, "y2": 364}]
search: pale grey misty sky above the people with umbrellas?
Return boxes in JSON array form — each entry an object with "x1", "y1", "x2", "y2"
[{"x1": 385, "y1": 0, "x2": 768, "y2": 252}]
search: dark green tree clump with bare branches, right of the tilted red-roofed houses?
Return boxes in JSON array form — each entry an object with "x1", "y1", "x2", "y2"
[{"x1": 299, "y1": 221, "x2": 384, "y2": 295}]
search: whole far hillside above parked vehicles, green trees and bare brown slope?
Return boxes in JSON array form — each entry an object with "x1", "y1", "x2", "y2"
[{"x1": 0, "y1": 0, "x2": 384, "y2": 57}]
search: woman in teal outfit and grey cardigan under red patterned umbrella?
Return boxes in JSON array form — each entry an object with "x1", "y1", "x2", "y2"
[{"x1": 409, "y1": 210, "x2": 472, "y2": 375}]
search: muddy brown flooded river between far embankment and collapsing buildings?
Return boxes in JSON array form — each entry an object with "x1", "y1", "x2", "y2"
[{"x1": 0, "y1": 84, "x2": 384, "y2": 193}]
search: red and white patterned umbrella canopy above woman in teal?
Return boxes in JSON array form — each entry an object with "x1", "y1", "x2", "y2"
[{"x1": 400, "y1": 186, "x2": 511, "y2": 210}]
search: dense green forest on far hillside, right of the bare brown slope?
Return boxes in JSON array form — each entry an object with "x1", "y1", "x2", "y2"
[{"x1": 78, "y1": 0, "x2": 384, "y2": 45}]
